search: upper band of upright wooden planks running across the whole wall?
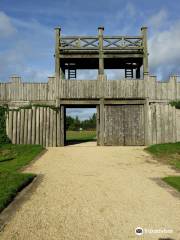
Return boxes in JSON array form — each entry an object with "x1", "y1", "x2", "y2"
[{"x1": 0, "y1": 75, "x2": 180, "y2": 101}]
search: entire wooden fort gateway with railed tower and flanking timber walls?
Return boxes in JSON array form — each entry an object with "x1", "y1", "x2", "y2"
[{"x1": 0, "y1": 27, "x2": 180, "y2": 146}]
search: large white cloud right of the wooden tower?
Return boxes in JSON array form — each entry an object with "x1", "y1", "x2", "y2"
[{"x1": 148, "y1": 14, "x2": 180, "y2": 79}]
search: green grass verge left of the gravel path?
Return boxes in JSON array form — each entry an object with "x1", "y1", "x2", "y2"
[{"x1": 0, "y1": 144, "x2": 43, "y2": 212}]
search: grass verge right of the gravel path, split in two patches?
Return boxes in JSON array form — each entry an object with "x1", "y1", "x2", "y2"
[{"x1": 146, "y1": 142, "x2": 180, "y2": 191}]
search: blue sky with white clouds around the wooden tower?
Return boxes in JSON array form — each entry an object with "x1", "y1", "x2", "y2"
[{"x1": 0, "y1": 0, "x2": 180, "y2": 118}]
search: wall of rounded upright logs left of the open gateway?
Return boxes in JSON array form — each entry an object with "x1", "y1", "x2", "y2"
[{"x1": 6, "y1": 107, "x2": 60, "y2": 147}]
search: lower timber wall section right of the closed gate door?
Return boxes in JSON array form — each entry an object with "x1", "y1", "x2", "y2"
[{"x1": 148, "y1": 103, "x2": 177, "y2": 144}]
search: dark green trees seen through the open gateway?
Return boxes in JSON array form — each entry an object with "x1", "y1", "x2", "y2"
[{"x1": 66, "y1": 113, "x2": 96, "y2": 131}]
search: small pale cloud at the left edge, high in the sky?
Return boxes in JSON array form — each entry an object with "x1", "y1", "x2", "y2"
[{"x1": 0, "y1": 12, "x2": 17, "y2": 38}]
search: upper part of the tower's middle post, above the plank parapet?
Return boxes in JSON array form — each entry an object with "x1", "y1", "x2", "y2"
[{"x1": 98, "y1": 27, "x2": 104, "y2": 75}]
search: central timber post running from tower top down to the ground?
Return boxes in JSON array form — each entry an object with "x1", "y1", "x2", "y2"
[{"x1": 98, "y1": 27, "x2": 104, "y2": 146}]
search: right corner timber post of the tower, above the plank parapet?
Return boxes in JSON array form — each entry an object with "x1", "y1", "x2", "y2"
[{"x1": 141, "y1": 27, "x2": 149, "y2": 75}]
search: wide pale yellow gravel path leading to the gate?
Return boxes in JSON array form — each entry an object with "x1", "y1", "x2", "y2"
[{"x1": 0, "y1": 143, "x2": 180, "y2": 240}]
